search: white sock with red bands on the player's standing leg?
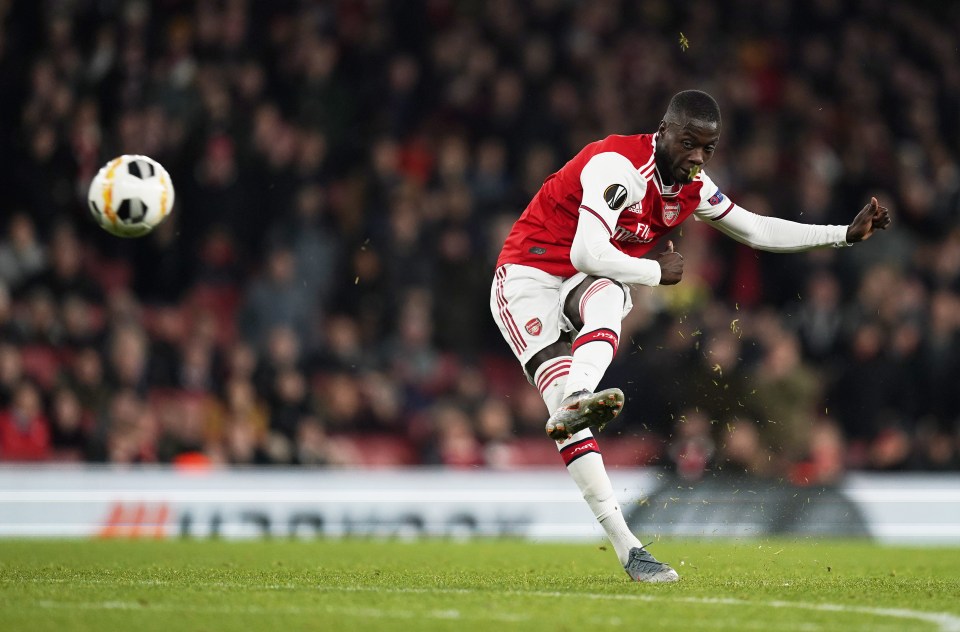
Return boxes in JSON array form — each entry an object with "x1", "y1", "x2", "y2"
[{"x1": 534, "y1": 356, "x2": 641, "y2": 564}]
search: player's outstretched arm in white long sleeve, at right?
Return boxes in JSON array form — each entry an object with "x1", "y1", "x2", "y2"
[{"x1": 707, "y1": 198, "x2": 890, "y2": 252}]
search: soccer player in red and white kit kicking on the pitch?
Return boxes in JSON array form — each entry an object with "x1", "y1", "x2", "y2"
[{"x1": 490, "y1": 90, "x2": 890, "y2": 582}]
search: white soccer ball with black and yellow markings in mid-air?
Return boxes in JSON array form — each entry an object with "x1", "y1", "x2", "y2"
[{"x1": 87, "y1": 155, "x2": 173, "y2": 237}]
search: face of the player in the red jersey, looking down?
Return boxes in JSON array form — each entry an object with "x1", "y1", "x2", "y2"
[{"x1": 657, "y1": 121, "x2": 720, "y2": 183}]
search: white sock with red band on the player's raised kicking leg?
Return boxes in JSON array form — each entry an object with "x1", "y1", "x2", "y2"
[{"x1": 564, "y1": 279, "x2": 624, "y2": 398}]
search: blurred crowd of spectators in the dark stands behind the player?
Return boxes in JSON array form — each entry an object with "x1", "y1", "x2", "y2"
[{"x1": 0, "y1": 0, "x2": 960, "y2": 476}]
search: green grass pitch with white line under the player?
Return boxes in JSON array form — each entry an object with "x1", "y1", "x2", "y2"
[{"x1": 0, "y1": 539, "x2": 960, "y2": 632}]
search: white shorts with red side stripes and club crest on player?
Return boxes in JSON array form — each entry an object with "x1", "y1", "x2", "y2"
[{"x1": 490, "y1": 263, "x2": 633, "y2": 379}]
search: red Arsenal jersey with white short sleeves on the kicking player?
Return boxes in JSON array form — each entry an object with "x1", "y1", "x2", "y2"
[{"x1": 497, "y1": 134, "x2": 733, "y2": 277}]
